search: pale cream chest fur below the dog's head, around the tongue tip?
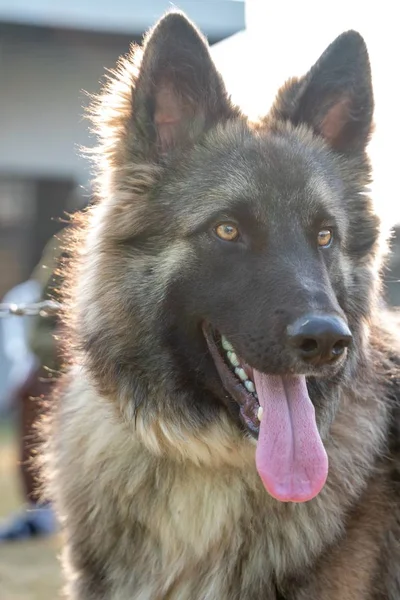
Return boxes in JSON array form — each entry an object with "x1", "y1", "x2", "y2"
[{"x1": 48, "y1": 368, "x2": 385, "y2": 600}]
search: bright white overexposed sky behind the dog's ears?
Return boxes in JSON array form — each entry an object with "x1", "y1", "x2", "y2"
[{"x1": 212, "y1": 0, "x2": 400, "y2": 223}]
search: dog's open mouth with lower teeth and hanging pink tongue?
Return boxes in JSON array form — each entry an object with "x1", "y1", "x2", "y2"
[{"x1": 203, "y1": 325, "x2": 328, "y2": 502}]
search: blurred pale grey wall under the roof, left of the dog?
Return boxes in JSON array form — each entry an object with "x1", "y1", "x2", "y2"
[{"x1": 0, "y1": 37, "x2": 128, "y2": 184}]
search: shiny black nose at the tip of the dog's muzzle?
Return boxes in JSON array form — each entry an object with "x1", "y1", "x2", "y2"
[{"x1": 287, "y1": 315, "x2": 352, "y2": 365}]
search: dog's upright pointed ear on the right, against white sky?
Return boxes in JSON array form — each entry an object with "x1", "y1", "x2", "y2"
[{"x1": 272, "y1": 31, "x2": 374, "y2": 153}]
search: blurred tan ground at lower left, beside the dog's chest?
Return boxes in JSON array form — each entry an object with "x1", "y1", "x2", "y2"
[{"x1": 0, "y1": 424, "x2": 61, "y2": 600}]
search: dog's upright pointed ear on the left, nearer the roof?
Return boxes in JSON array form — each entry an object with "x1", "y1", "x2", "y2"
[{"x1": 131, "y1": 13, "x2": 233, "y2": 159}]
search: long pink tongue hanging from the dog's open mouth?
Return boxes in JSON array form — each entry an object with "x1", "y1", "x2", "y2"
[{"x1": 253, "y1": 370, "x2": 328, "y2": 502}]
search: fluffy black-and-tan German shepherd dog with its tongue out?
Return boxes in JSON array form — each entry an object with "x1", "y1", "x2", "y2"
[{"x1": 47, "y1": 12, "x2": 400, "y2": 600}]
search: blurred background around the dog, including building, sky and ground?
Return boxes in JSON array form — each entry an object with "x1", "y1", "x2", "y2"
[{"x1": 0, "y1": 0, "x2": 400, "y2": 600}]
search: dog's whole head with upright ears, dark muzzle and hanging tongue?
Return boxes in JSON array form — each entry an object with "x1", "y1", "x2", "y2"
[{"x1": 81, "y1": 14, "x2": 378, "y2": 500}]
